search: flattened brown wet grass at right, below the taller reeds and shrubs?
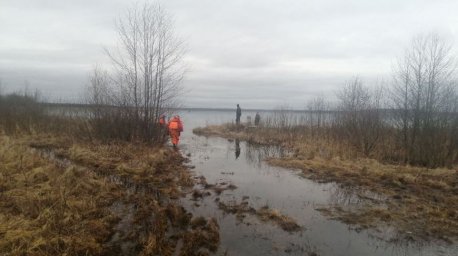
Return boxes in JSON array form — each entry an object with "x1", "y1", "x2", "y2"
[{"x1": 269, "y1": 157, "x2": 458, "y2": 241}]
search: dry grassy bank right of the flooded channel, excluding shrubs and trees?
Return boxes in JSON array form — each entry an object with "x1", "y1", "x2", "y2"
[{"x1": 194, "y1": 124, "x2": 458, "y2": 242}]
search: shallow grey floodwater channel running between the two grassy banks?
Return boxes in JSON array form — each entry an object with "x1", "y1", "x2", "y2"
[{"x1": 180, "y1": 111, "x2": 458, "y2": 256}]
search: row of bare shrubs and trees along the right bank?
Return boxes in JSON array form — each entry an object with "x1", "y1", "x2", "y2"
[{"x1": 264, "y1": 33, "x2": 458, "y2": 167}]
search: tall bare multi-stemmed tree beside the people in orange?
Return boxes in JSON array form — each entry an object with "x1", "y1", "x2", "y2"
[{"x1": 87, "y1": 2, "x2": 184, "y2": 142}]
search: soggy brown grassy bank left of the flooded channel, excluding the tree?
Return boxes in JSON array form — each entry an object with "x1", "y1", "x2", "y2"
[{"x1": 0, "y1": 134, "x2": 219, "y2": 255}]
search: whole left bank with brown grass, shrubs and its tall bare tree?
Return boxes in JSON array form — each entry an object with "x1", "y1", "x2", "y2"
[{"x1": 0, "y1": 3, "x2": 215, "y2": 255}]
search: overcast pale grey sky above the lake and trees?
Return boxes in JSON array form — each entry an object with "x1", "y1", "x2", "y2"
[{"x1": 0, "y1": 0, "x2": 458, "y2": 109}]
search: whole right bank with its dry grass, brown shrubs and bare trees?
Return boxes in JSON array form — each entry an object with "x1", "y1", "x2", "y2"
[{"x1": 194, "y1": 34, "x2": 458, "y2": 244}]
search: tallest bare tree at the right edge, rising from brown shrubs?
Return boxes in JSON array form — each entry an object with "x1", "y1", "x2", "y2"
[{"x1": 391, "y1": 34, "x2": 456, "y2": 165}]
